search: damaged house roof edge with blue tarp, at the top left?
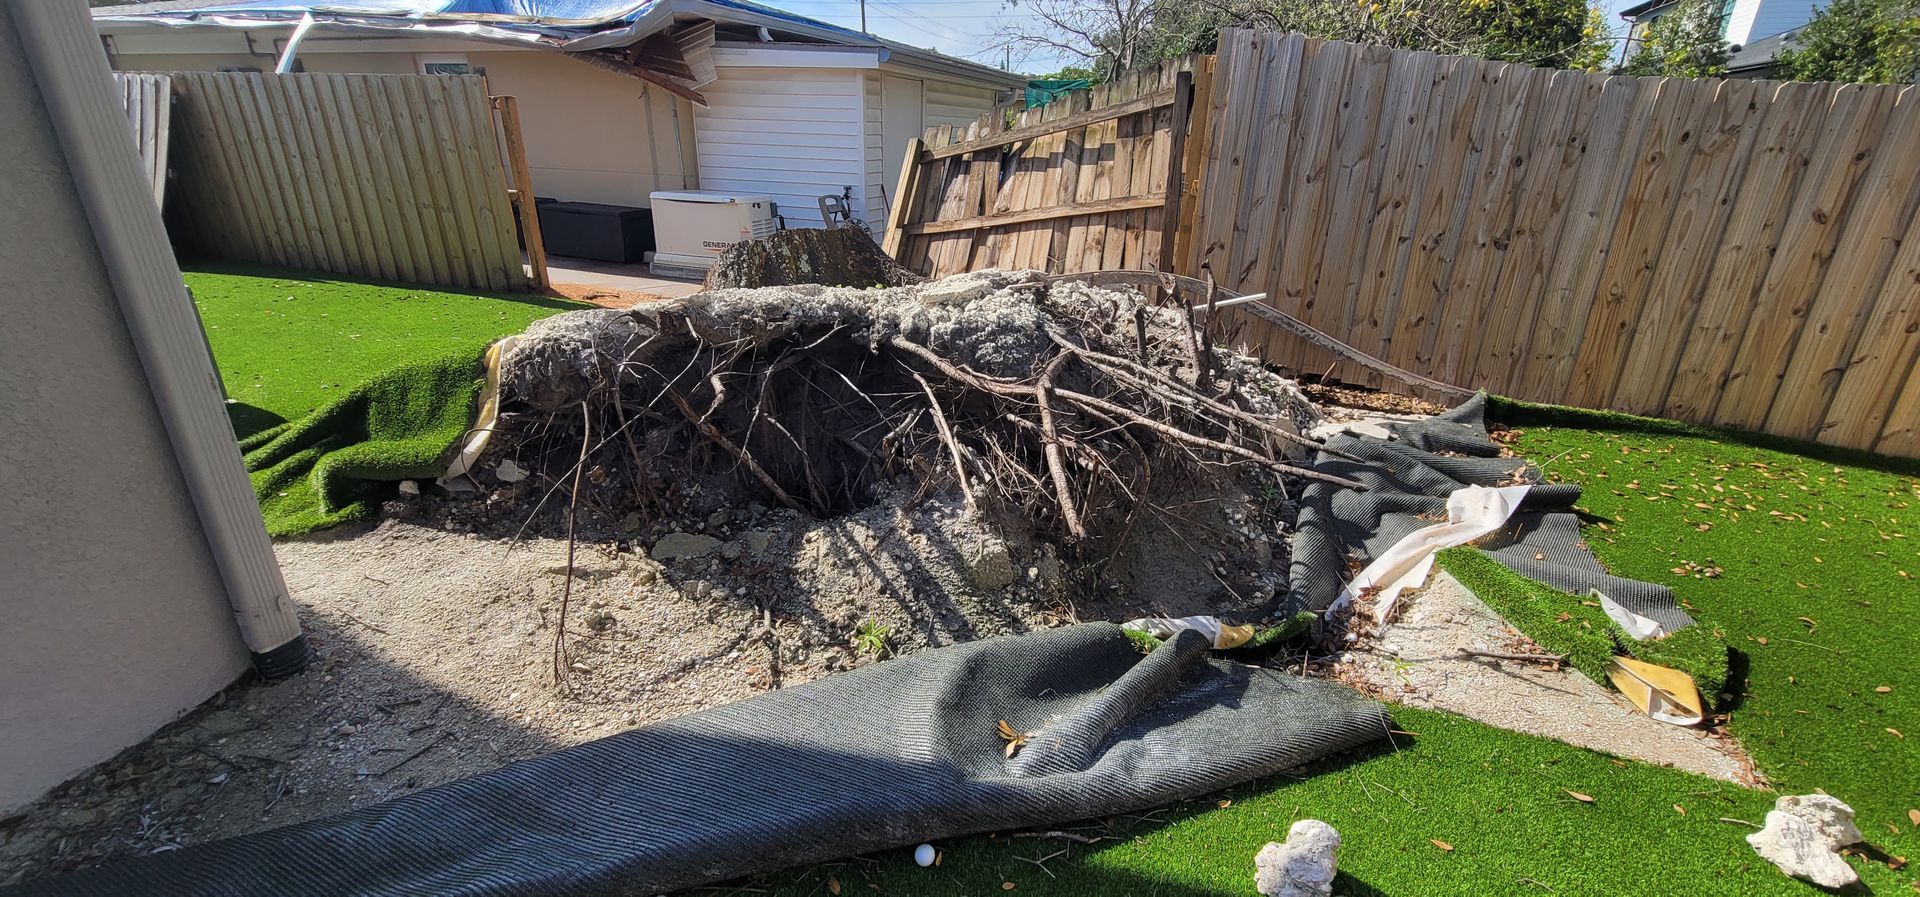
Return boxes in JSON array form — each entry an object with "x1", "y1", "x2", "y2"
[{"x1": 92, "y1": 0, "x2": 1025, "y2": 88}]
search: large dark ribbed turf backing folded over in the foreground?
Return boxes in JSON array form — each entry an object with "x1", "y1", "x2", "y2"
[{"x1": 18, "y1": 622, "x2": 1388, "y2": 897}]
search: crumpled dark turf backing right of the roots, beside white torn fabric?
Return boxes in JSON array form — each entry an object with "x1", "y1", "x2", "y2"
[{"x1": 1286, "y1": 394, "x2": 1693, "y2": 632}]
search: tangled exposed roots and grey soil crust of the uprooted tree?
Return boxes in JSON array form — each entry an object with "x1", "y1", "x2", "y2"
[{"x1": 490, "y1": 271, "x2": 1357, "y2": 544}]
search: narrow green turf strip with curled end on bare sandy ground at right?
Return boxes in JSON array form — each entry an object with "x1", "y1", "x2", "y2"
[{"x1": 1438, "y1": 547, "x2": 1726, "y2": 705}]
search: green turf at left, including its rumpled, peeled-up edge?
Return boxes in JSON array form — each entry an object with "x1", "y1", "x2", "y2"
[{"x1": 186, "y1": 269, "x2": 586, "y2": 536}]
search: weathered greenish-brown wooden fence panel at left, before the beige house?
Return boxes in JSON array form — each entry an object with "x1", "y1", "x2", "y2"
[{"x1": 158, "y1": 71, "x2": 530, "y2": 290}]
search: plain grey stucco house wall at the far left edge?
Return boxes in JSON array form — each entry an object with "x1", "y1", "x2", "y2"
[{"x1": 0, "y1": 4, "x2": 248, "y2": 814}]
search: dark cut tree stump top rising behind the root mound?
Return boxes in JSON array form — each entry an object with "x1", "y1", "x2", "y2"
[{"x1": 707, "y1": 227, "x2": 922, "y2": 290}]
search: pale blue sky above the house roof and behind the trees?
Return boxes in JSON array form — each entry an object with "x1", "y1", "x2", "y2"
[{"x1": 760, "y1": 0, "x2": 1638, "y2": 73}]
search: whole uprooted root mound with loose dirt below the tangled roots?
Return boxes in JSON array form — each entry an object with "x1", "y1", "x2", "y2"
[{"x1": 412, "y1": 271, "x2": 1351, "y2": 676}]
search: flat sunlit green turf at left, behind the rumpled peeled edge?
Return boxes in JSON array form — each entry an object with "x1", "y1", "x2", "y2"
[{"x1": 186, "y1": 267, "x2": 586, "y2": 438}]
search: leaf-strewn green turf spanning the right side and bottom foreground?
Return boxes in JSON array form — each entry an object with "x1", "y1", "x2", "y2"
[{"x1": 755, "y1": 403, "x2": 1920, "y2": 897}]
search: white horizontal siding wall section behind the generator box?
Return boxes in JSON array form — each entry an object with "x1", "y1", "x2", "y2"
[{"x1": 693, "y1": 67, "x2": 868, "y2": 227}]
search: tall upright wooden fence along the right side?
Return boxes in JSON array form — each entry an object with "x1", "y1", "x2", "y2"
[{"x1": 1190, "y1": 31, "x2": 1920, "y2": 455}]
